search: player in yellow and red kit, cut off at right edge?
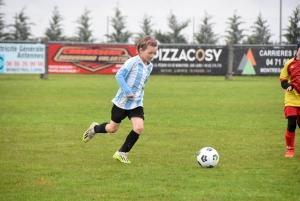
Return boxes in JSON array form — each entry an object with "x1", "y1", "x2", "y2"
[{"x1": 280, "y1": 41, "x2": 300, "y2": 157}]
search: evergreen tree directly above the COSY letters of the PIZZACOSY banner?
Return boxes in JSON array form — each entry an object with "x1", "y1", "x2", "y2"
[{"x1": 195, "y1": 12, "x2": 219, "y2": 44}]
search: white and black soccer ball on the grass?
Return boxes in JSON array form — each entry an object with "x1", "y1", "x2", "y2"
[{"x1": 197, "y1": 147, "x2": 220, "y2": 168}]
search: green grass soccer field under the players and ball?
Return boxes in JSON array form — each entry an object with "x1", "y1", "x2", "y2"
[{"x1": 0, "y1": 74, "x2": 300, "y2": 201}]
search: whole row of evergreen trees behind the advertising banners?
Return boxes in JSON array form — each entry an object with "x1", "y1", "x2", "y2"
[{"x1": 0, "y1": 0, "x2": 300, "y2": 44}]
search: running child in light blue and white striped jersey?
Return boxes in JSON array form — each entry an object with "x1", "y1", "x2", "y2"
[{"x1": 83, "y1": 36, "x2": 158, "y2": 163}]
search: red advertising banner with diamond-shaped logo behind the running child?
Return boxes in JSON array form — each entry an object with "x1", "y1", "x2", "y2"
[{"x1": 48, "y1": 43, "x2": 136, "y2": 74}]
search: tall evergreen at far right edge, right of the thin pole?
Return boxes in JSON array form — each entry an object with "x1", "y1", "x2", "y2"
[{"x1": 283, "y1": 5, "x2": 300, "y2": 44}]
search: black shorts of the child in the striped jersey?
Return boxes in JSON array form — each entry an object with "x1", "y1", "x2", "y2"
[{"x1": 111, "y1": 104, "x2": 145, "y2": 123}]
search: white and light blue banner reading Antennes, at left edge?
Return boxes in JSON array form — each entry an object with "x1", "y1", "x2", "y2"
[{"x1": 0, "y1": 43, "x2": 45, "y2": 74}]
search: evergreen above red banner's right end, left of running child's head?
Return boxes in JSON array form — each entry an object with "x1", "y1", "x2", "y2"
[{"x1": 106, "y1": 7, "x2": 133, "y2": 43}]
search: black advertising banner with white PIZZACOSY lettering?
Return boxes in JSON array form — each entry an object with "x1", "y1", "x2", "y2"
[{"x1": 152, "y1": 45, "x2": 228, "y2": 75}]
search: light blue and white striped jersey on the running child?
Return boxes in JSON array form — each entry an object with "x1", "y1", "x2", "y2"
[{"x1": 112, "y1": 55, "x2": 153, "y2": 110}]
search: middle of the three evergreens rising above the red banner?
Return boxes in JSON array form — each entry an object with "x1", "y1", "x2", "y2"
[{"x1": 74, "y1": 8, "x2": 95, "y2": 42}]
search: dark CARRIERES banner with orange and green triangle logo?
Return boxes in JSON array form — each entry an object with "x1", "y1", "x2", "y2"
[{"x1": 233, "y1": 45, "x2": 297, "y2": 75}]
